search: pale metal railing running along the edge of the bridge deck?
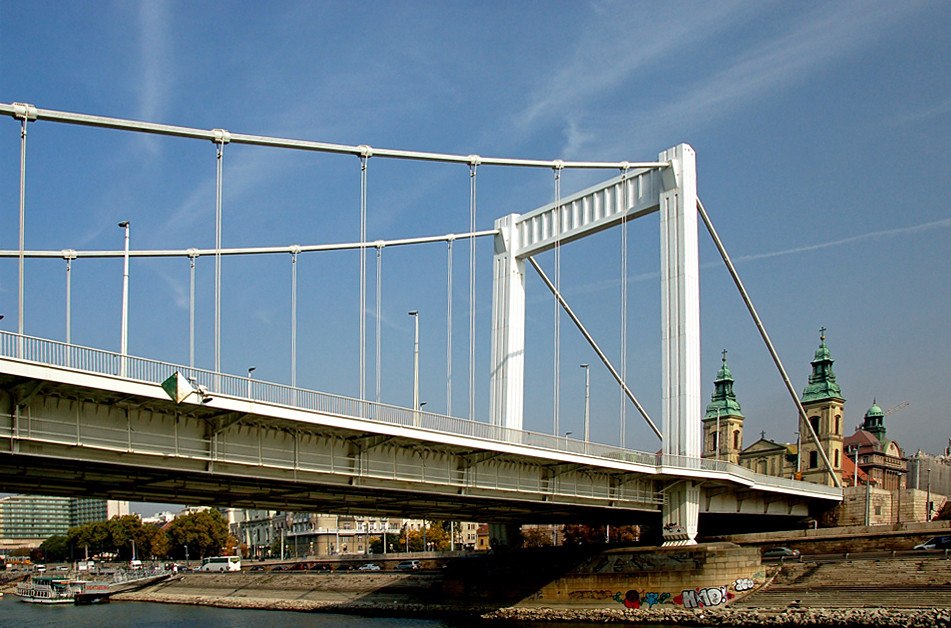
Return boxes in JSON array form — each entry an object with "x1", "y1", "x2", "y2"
[{"x1": 0, "y1": 331, "x2": 821, "y2": 492}]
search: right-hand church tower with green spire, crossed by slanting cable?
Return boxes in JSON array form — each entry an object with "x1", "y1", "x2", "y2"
[{"x1": 799, "y1": 327, "x2": 845, "y2": 485}]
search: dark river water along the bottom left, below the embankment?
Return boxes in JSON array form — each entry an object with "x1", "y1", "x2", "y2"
[{"x1": 0, "y1": 594, "x2": 636, "y2": 628}]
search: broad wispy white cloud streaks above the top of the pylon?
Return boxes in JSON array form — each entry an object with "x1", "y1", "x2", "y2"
[{"x1": 513, "y1": 3, "x2": 924, "y2": 158}]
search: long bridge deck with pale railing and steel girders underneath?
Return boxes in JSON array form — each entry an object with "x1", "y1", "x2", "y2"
[{"x1": 0, "y1": 332, "x2": 841, "y2": 523}]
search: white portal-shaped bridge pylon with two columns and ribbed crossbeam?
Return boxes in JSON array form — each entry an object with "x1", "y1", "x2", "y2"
[{"x1": 489, "y1": 144, "x2": 701, "y2": 543}]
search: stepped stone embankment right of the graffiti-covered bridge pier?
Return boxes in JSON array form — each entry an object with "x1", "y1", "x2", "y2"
[{"x1": 731, "y1": 557, "x2": 951, "y2": 608}]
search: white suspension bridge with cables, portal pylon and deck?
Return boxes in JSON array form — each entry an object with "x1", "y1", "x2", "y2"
[{"x1": 0, "y1": 103, "x2": 841, "y2": 543}]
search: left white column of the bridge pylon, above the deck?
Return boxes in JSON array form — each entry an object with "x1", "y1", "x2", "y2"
[{"x1": 489, "y1": 214, "x2": 525, "y2": 430}]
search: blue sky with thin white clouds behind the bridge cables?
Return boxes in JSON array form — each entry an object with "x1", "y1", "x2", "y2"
[{"x1": 0, "y1": 0, "x2": 951, "y2": 516}]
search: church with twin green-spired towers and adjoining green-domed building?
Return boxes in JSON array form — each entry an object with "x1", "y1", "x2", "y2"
[{"x1": 702, "y1": 328, "x2": 907, "y2": 490}]
